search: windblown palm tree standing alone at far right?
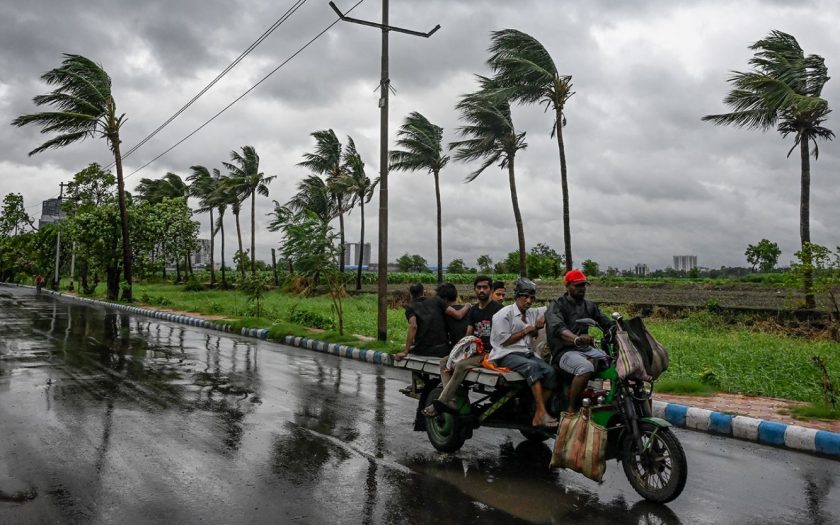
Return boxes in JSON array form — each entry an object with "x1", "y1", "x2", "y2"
[{"x1": 703, "y1": 31, "x2": 834, "y2": 308}]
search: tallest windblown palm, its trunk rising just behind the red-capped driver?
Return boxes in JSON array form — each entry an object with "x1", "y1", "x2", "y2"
[{"x1": 487, "y1": 29, "x2": 574, "y2": 271}]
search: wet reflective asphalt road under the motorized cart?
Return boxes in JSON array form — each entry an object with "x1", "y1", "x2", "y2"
[{"x1": 0, "y1": 287, "x2": 840, "y2": 525}]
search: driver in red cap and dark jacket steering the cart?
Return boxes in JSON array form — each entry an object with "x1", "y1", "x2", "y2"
[{"x1": 545, "y1": 270, "x2": 614, "y2": 412}]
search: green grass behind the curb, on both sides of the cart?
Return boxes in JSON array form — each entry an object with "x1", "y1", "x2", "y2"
[{"x1": 80, "y1": 283, "x2": 840, "y2": 403}]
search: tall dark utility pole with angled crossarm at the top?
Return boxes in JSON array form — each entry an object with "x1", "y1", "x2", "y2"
[{"x1": 330, "y1": 0, "x2": 440, "y2": 341}]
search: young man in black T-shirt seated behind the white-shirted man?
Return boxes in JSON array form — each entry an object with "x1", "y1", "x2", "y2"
[{"x1": 423, "y1": 275, "x2": 502, "y2": 417}]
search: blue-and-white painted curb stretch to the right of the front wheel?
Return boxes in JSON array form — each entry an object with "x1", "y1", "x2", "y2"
[{"x1": 653, "y1": 401, "x2": 840, "y2": 459}]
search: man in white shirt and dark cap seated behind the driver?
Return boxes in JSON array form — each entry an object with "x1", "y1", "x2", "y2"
[{"x1": 488, "y1": 278, "x2": 558, "y2": 427}]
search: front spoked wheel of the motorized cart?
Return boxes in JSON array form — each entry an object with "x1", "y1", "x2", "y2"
[{"x1": 621, "y1": 422, "x2": 688, "y2": 503}]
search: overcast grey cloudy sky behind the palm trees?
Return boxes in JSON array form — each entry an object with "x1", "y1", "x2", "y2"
[{"x1": 0, "y1": 0, "x2": 840, "y2": 269}]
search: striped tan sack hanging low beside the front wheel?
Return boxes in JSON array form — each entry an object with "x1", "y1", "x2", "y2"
[{"x1": 549, "y1": 408, "x2": 607, "y2": 481}]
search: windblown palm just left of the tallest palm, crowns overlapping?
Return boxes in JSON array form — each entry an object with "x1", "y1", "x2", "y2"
[{"x1": 449, "y1": 76, "x2": 528, "y2": 277}]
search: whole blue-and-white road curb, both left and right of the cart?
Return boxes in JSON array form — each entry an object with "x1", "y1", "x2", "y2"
[{"x1": 0, "y1": 283, "x2": 840, "y2": 459}]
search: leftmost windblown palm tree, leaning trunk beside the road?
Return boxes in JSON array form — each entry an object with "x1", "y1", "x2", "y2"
[{"x1": 12, "y1": 54, "x2": 132, "y2": 301}]
